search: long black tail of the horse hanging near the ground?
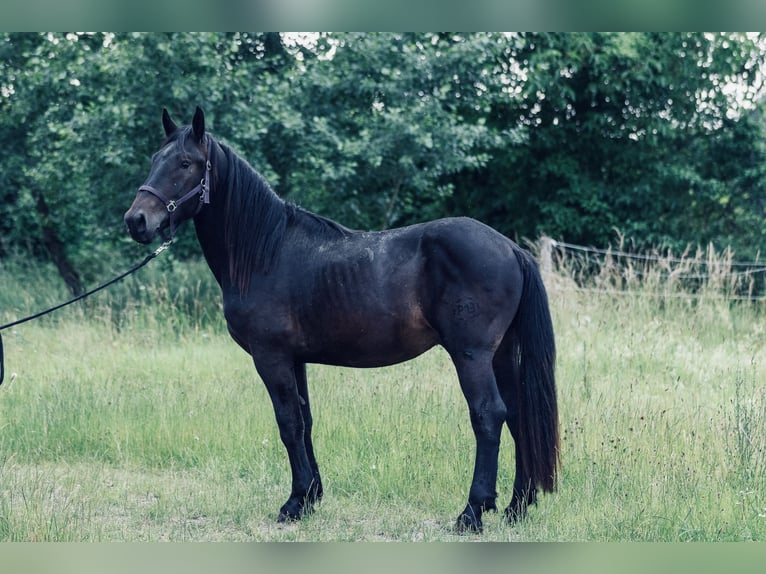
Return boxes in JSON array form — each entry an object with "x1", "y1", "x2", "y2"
[{"x1": 508, "y1": 248, "x2": 559, "y2": 492}]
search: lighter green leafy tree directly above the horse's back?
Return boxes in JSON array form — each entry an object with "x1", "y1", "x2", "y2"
[{"x1": 267, "y1": 34, "x2": 498, "y2": 229}]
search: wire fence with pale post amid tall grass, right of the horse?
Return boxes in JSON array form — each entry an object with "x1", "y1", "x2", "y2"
[{"x1": 536, "y1": 237, "x2": 766, "y2": 301}]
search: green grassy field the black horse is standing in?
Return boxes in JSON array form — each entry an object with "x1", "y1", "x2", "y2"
[{"x1": 0, "y1": 246, "x2": 766, "y2": 541}]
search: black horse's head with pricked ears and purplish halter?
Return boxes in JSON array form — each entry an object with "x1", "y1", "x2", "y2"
[{"x1": 125, "y1": 107, "x2": 212, "y2": 243}]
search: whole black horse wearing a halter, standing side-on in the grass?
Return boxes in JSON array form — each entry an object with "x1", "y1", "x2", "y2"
[{"x1": 125, "y1": 108, "x2": 559, "y2": 531}]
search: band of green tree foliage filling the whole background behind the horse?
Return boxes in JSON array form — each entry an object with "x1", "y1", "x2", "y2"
[{"x1": 0, "y1": 33, "x2": 766, "y2": 283}]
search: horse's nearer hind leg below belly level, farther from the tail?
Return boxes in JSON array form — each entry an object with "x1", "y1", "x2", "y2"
[{"x1": 452, "y1": 350, "x2": 506, "y2": 532}]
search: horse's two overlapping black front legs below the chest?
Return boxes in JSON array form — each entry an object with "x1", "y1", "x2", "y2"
[{"x1": 253, "y1": 353, "x2": 321, "y2": 522}]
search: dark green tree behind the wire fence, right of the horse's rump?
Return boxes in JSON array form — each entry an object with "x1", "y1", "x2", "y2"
[{"x1": 452, "y1": 34, "x2": 764, "y2": 256}]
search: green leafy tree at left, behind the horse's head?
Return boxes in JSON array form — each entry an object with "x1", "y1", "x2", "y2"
[{"x1": 0, "y1": 34, "x2": 296, "y2": 293}]
